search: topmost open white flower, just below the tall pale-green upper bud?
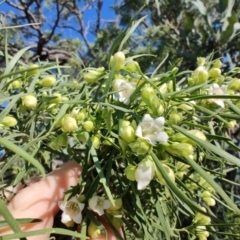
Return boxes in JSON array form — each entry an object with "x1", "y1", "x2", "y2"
[{"x1": 114, "y1": 79, "x2": 136, "y2": 104}]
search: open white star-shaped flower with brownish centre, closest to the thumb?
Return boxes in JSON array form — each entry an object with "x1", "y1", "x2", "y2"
[{"x1": 58, "y1": 197, "x2": 85, "y2": 224}]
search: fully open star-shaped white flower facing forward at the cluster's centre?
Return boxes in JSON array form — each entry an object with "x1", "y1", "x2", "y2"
[{"x1": 136, "y1": 114, "x2": 168, "y2": 145}]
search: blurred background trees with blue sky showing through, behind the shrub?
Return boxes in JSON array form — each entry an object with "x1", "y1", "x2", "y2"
[{"x1": 2, "y1": 0, "x2": 240, "y2": 73}]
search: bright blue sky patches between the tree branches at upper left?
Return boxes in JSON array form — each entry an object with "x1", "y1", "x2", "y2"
[{"x1": 0, "y1": 0, "x2": 115, "y2": 42}]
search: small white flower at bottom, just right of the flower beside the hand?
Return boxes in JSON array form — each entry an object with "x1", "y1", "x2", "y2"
[{"x1": 88, "y1": 196, "x2": 112, "y2": 216}]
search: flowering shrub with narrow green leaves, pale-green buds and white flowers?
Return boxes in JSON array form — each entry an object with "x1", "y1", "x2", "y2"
[{"x1": 0, "y1": 20, "x2": 240, "y2": 240}]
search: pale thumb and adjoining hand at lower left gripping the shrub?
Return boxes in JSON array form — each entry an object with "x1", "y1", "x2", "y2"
[{"x1": 0, "y1": 161, "x2": 81, "y2": 240}]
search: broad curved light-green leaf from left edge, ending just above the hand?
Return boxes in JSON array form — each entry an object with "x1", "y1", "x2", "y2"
[{"x1": 0, "y1": 137, "x2": 45, "y2": 176}]
